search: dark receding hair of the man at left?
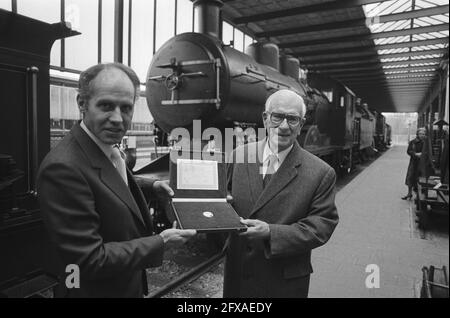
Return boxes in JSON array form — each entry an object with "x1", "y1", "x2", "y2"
[{"x1": 78, "y1": 63, "x2": 141, "y2": 101}]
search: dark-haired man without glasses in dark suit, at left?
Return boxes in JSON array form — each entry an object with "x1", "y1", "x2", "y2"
[{"x1": 37, "y1": 63, "x2": 196, "y2": 297}]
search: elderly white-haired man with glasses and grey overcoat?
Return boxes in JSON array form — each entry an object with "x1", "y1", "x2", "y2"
[{"x1": 224, "y1": 90, "x2": 338, "y2": 298}]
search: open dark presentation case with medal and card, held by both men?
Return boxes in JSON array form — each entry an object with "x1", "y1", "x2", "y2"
[{"x1": 169, "y1": 150, "x2": 246, "y2": 233}]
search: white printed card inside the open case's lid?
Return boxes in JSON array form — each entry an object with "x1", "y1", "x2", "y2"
[{"x1": 177, "y1": 159, "x2": 219, "y2": 190}]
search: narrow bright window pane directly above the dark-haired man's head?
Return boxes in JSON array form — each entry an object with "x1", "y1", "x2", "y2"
[{"x1": 101, "y1": 0, "x2": 114, "y2": 62}]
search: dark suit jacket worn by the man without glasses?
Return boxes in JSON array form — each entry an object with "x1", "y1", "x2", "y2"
[{"x1": 37, "y1": 124, "x2": 164, "y2": 297}]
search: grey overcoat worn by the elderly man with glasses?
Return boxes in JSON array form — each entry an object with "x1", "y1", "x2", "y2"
[{"x1": 225, "y1": 142, "x2": 338, "y2": 297}]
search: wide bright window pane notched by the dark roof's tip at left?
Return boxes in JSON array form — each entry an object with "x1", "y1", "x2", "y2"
[{"x1": 65, "y1": 0, "x2": 98, "y2": 70}]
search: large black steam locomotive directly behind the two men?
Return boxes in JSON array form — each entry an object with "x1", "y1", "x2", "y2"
[{"x1": 139, "y1": 1, "x2": 386, "y2": 179}]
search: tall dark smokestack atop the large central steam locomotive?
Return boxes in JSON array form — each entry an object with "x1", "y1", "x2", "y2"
[{"x1": 194, "y1": 0, "x2": 223, "y2": 39}]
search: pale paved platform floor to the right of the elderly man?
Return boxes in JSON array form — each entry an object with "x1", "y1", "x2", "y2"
[{"x1": 309, "y1": 146, "x2": 449, "y2": 298}]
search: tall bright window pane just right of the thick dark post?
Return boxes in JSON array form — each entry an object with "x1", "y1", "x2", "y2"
[{"x1": 131, "y1": 0, "x2": 154, "y2": 83}]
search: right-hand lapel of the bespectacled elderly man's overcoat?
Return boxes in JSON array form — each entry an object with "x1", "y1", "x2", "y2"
[{"x1": 249, "y1": 142, "x2": 301, "y2": 217}]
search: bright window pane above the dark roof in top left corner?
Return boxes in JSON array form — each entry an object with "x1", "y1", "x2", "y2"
[{"x1": 17, "y1": 0, "x2": 61, "y2": 23}]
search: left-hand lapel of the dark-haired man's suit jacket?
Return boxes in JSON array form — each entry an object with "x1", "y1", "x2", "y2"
[{"x1": 71, "y1": 124, "x2": 145, "y2": 225}]
